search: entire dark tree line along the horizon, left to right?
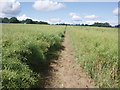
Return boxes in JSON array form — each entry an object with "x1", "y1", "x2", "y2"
[{"x1": 0, "y1": 17, "x2": 120, "y2": 27}]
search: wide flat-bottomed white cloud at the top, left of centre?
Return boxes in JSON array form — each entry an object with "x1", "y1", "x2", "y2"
[{"x1": 33, "y1": 0, "x2": 64, "y2": 11}]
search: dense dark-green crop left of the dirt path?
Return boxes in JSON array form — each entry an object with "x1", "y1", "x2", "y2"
[{"x1": 2, "y1": 24, "x2": 64, "y2": 88}]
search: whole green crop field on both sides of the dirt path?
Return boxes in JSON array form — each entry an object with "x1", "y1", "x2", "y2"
[{"x1": 2, "y1": 24, "x2": 118, "y2": 88}]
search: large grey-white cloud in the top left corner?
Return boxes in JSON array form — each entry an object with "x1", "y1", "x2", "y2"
[{"x1": 0, "y1": 0, "x2": 21, "y2": 17}]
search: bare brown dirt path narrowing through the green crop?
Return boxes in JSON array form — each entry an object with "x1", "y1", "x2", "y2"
[{"x1": 45, "y1": 34, "x2": 94, "y2": 88}]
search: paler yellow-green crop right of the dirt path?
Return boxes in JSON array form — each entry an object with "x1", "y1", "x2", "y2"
[{"x1": 67, "y1": 26, "x2": 119, "y2": 88}]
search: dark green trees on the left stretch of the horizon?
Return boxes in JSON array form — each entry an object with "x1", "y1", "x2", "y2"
[{"x1": 0, "y1": 17, "x2": 48, "y2": 24}]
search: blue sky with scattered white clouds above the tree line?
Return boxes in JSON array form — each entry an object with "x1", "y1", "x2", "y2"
[{"x1": 0, "y1": 0, "x2": 119, "y2": 25}]
